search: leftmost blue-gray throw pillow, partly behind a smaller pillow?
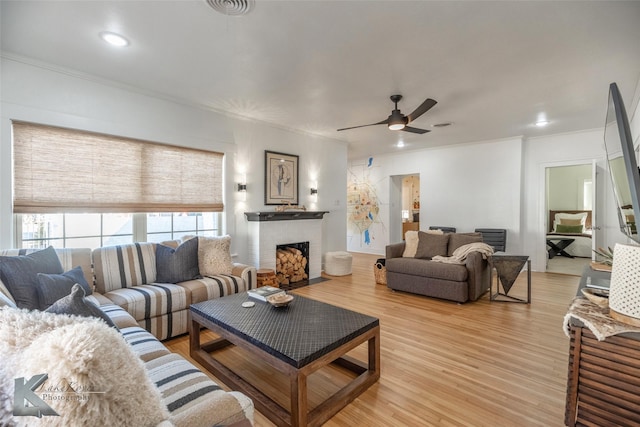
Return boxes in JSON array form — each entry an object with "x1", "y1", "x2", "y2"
[{"x1": 0, "y1": 246, "x2": 64, "y2": 310}]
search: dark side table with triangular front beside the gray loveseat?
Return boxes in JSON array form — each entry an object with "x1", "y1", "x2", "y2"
[{"x1": 489, "y1": 254, "x2": 531, "y2": 304}]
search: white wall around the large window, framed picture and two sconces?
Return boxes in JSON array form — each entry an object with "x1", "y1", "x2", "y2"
[{"x1": 0, "y1": 58, "x2": 347, "y2": 261}]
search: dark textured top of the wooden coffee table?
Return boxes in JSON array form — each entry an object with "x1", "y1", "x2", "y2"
[{"x1": 191, "y1": 292, "x2": 379, "y2": 368}]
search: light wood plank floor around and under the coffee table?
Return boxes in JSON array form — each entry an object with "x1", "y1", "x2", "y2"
[{"x1": 167, "y1": 253, "x2": 579, "y2": 427}]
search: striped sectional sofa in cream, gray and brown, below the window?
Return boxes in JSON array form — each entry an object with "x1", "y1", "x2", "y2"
[{"x1": 0, "y1": 243, "x2": 256, "y2": 427}]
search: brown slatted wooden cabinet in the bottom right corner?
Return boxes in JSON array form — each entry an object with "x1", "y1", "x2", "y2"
[{"x1": 565, "y1": 269, "x2": 640, "y2": 426}]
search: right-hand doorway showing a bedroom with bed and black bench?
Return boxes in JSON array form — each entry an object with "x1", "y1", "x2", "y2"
[{"x1": 543, "y1": 163, "x2": 597, "y2": 276}]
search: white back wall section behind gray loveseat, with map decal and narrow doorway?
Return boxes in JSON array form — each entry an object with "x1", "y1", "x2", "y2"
[{"x1": 347, "y1": 138, "x2": 522, "y2": 254}]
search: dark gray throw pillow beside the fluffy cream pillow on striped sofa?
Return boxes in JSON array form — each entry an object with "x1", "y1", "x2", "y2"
[{"x1": 156, "y1": 239, "x2": 200, "y2": 283}]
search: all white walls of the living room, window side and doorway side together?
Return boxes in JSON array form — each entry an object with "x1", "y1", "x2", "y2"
[{"x1": 0, "y1": 58, "x2": 640, "y2": 271}]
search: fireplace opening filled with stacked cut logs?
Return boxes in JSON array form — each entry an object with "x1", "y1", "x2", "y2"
[{"x1": 276, "y1": 242, "x2": 309, "y2": 288}]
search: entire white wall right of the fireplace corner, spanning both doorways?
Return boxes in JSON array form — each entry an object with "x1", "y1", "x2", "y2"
[{"x1": 347, "y1": 129, "x2": 628, "y2": 271}]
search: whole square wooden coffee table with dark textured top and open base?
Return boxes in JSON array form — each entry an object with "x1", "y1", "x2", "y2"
[{"x1": 189, "y1": 293, "x2": 380, "y2": 426}]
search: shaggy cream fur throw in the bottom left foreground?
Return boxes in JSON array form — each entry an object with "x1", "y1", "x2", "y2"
[{"x1": 0, "y1": 307, "x2": 169, "y2": 427}]
